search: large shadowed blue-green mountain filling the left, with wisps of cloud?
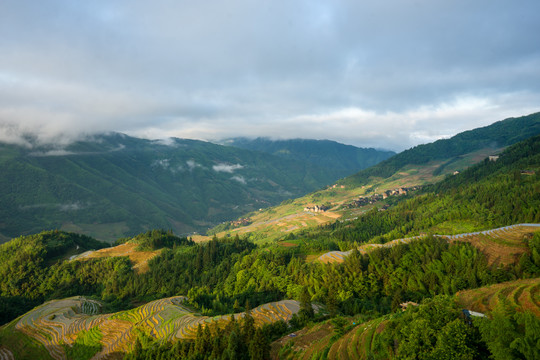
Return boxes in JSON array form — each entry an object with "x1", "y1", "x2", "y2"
[{"x1": 0, "y1": 133, "x2": 354, "y2": 241}]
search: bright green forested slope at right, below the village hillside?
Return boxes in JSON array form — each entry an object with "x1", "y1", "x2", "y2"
[{"x1": 296, "y1": 136, "x2": 540, "y2": 255}]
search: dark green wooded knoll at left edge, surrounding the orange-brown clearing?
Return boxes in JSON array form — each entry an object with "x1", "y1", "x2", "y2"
[{"x1": 0, "y1": 231, "x2": 126, "y2": 323}]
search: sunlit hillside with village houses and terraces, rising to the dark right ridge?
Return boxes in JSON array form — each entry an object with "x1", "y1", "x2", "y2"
[{"x1": 206, "y1": 114, "x2": 540, "y2": 241}]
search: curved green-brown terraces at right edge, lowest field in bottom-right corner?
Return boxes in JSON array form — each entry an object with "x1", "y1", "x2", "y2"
[{"x1": 456, "y1": 278, "x2": 540, "y2": 317}]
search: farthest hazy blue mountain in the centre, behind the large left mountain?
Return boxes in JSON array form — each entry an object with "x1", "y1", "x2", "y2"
[{"x1": 224, "y1": 137, "x2": 395, "y2": 177}]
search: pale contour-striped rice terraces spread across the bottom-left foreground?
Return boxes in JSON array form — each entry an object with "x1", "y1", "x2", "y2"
[{"x1": 0, "y1": 296, "x2": 300, "y2": 360}]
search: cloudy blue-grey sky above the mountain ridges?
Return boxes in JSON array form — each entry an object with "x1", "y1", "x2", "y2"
[{"x1": 0, "y1": 0, "x2": 540, "y2": 150}]
